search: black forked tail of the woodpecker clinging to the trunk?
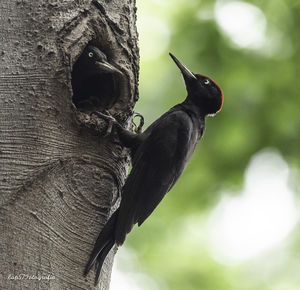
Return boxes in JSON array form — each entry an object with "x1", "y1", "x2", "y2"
[{"x1": 84, "y1": 210, "x2": 119, "y2": 284}]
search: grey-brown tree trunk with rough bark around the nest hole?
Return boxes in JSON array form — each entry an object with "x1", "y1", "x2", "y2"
[{"x1": 0, "y1": 0, "x2": 138, "y2": 290}]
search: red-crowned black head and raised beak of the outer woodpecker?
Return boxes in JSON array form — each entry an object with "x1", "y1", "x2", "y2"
[{"x1": 170, "y1": 53, "x2": 223, "y2": 115}]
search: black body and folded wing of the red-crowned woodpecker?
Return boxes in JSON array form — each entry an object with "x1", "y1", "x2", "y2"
[{"x1": 115, "y1": 107, "x2": 200, "y2": 244}]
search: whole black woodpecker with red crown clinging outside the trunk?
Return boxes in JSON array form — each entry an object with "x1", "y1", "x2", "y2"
[{"x1": 84, "y1": 53, "x2": 223, "y2": 283}]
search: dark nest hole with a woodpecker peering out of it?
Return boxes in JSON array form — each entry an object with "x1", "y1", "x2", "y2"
[{"x1": 72, "y1": 45, "x2": 123, "y2": 111}]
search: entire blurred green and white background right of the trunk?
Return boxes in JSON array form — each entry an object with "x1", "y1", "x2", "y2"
[{"x1": 111, "y1": 0, "x2": 300, "y2": 290}]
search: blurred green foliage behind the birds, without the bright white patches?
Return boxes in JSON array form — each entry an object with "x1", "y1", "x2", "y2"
[{"x1": 118, "y1": 0, "x2": 300, "y2": 290}]
